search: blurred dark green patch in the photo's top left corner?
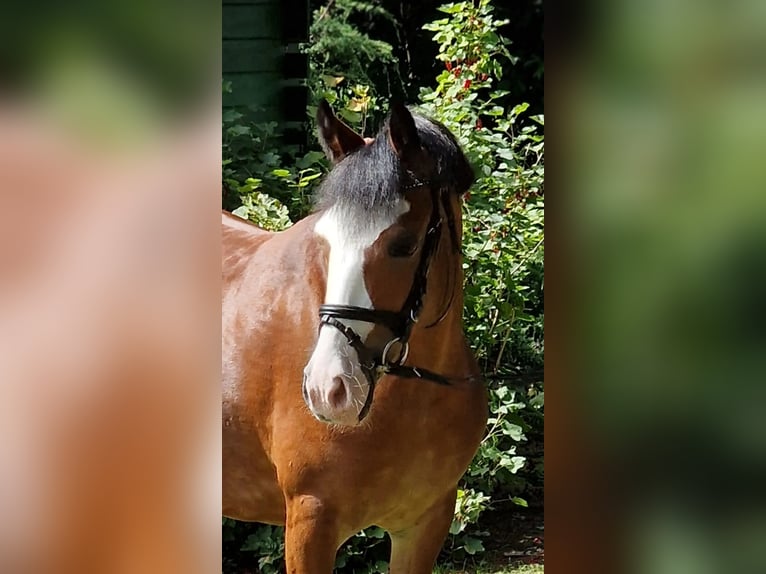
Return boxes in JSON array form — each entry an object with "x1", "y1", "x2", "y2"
[{"x1": 0, "y1": 0, "x2": 221, "y2": 145}]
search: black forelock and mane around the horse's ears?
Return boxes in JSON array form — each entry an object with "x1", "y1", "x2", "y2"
[{"x1": 317, "y1": 114, "x2": 474, "y2": 217}]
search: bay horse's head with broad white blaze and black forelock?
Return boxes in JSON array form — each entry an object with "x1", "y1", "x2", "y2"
[{"x1": 303, "y1": 101, "x2": 473, "y2": 425}]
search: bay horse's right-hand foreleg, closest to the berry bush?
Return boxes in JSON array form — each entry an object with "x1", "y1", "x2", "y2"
[{"x1": 390, "y1": 490, "x2": 457, "y2": 574}]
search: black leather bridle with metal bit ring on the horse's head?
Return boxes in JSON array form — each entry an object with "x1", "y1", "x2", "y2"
[{"x1": 319, "y1": 171, "x2": 478, "y2": 421}]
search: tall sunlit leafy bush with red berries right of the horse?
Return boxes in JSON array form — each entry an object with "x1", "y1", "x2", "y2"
[{"x1": 414, "y1": 0, "x2": 544, "y2": 560}]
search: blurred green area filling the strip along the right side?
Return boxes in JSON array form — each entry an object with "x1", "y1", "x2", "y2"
[{"x1": 560, "y1": 0, "x2": 766, "y2": 574}]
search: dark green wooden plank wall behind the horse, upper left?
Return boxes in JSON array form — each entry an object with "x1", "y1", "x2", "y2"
[{"x1": 222, "y1": 0, "x2": 309, "y2": 128}]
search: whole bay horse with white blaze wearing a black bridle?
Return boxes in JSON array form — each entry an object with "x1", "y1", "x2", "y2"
[{"x1": 222, "y1": 102, "x2": 487, "y2": 574}]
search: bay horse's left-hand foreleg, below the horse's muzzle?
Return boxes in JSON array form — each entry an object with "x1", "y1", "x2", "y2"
[{"x1": 285, "y1": 495, "x2": 339, "y2": 574}]
